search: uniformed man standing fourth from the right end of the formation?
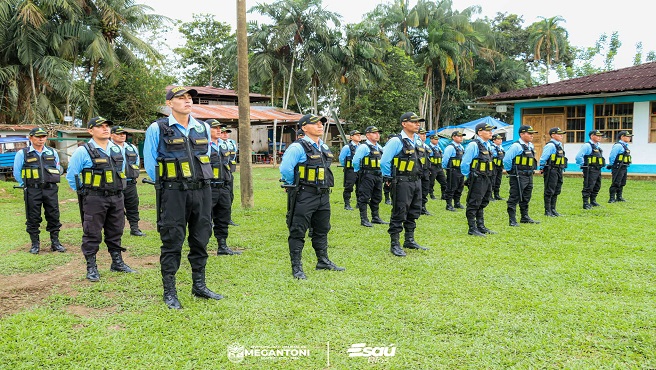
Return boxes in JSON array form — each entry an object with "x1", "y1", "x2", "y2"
[{"x1": 503, "y1": 125, "x2": 540, "y2": 226}]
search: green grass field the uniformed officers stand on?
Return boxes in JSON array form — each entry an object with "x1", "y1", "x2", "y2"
[{"x1": 0, "y1": 168, "x2": 656, "y2": 369}]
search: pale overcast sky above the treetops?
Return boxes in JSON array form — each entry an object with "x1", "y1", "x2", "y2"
[{"x1": 137, "y1": 0, "x2": 656, "y2": 68}]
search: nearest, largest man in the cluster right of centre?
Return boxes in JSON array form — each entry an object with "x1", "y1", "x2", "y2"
[{"x1": 380, "y1": 112, "x2": 428, "y2": 257}]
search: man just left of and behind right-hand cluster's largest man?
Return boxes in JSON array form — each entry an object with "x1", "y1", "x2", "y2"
[{"x1": 353, "y1": 126, "x2": 387, "y2": 227}]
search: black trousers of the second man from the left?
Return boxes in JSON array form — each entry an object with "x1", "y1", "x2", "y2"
[{"x1": 82, "y1": 193, "x2": 125, "y2": 256}]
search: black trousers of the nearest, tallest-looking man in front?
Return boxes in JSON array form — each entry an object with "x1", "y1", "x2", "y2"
[{"x1": 158, "y1": 186, "x2": 212, "y2": 276}]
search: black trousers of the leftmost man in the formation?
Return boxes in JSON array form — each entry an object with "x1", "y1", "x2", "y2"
[{"x1": 25, "y1": 184, "x2": 61, "y2": 241}]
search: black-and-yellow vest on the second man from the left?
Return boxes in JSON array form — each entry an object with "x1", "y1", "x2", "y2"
[{"x1": 82, "y1": 143, "x2": 126, "y2": 192}]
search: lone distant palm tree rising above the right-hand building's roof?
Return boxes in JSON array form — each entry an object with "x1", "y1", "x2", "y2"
[{"x1": 529, "y1": 16, "x2": 568, "y2": 83}]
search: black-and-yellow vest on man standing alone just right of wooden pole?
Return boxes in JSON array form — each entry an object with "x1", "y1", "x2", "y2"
[{"x1": 294, "y1": 140, "x2": 335, "y2": 189}]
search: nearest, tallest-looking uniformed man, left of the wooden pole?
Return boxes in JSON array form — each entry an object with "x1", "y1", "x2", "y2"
[{"x1": 144, "y1": 87, "x2": 223, "y2": 309}]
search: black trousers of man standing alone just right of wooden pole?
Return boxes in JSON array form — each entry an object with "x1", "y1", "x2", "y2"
[{"x1": 287, "y1": 186, "x2": 330, "y2": 259}]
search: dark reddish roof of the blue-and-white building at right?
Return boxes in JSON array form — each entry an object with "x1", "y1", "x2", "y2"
[{"x1": 477, "y1": 62, "x2": 656, "y2": 101}]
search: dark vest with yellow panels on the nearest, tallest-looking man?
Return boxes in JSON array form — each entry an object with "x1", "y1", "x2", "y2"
[{"x1": 157, "y1": 118, "x2": 214, "y2": 182}]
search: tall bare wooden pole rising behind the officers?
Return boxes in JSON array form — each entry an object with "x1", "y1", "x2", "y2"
[{"x1": 237, "y1": 0, "x2": 254, "y2": 208}]
